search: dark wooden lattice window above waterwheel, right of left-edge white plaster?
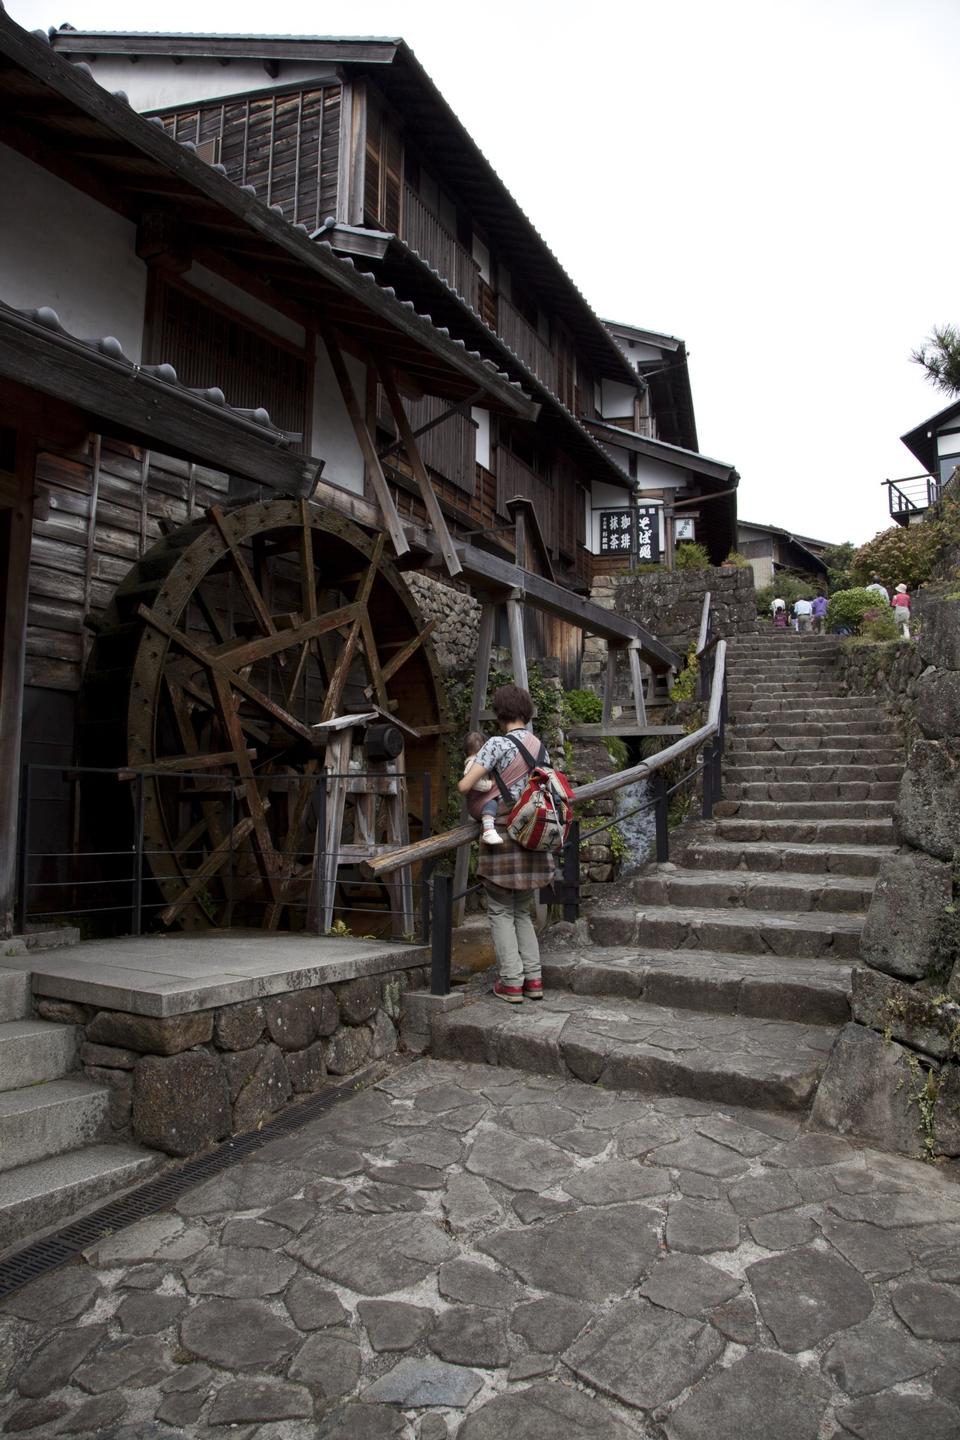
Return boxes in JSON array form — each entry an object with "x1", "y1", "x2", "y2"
[{"x1": 150, "y1": 279, "x2": 309, "y2": 448}]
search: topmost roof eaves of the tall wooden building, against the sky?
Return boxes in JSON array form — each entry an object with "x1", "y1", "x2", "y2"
[{"x1": 50, "y1": 30, "x2": 636, "y2": 394}]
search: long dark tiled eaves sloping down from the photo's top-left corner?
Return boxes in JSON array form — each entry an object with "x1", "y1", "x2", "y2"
[{"x1": 0, "y1": 12, "x2": 537, "y2": 419}]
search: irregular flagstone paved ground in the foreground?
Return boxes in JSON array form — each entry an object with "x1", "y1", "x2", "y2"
[{"x1": 0, "y1": 1060, "x2": 960, "y2": 1440}]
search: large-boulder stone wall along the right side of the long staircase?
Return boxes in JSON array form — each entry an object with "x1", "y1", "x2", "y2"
[{"x1": 813, "y1": 598, "x2": 960, "y2": 1158}]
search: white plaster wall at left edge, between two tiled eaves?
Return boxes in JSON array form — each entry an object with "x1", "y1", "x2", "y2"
[{"x1": 0, "y1": 145, "x2": 147, "y2": 363}]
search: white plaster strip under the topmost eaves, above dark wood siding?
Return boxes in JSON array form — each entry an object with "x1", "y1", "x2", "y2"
[{"x1": 77, "y1": 55, "x2": 334, "y2": 109}]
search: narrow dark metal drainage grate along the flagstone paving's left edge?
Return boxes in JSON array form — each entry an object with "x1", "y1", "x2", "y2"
[{"x1": 0, "y1": 1067, "x2": 379, "y2": 1300}]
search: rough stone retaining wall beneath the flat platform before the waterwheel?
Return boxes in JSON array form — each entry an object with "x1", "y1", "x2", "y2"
[{"x1": 36, "y1": 966, "x2": 429, "y2": 1155}]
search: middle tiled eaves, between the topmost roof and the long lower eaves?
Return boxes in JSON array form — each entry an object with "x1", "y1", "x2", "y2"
[{"x1": 314, "y1": 222, "x2": 629, "y2": 485}]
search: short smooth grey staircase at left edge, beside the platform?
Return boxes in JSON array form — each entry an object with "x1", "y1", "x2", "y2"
[{"x1": 0, "y1": 960, "x2": 157, "y2": 1253}]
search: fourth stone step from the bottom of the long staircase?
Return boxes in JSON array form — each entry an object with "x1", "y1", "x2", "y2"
[{"x1": 629, "y1": 865, "x2": 874, "y2": 917}]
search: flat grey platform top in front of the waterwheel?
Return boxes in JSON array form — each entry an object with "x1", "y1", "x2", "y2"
[{"x1": 0, "y1": 930, "x2": 429, "y2": 1017}]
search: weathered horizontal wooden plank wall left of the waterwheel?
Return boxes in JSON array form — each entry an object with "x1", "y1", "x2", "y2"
[{"x1": 24, "y1": 435, "x2": 229, "y2": 691}]
